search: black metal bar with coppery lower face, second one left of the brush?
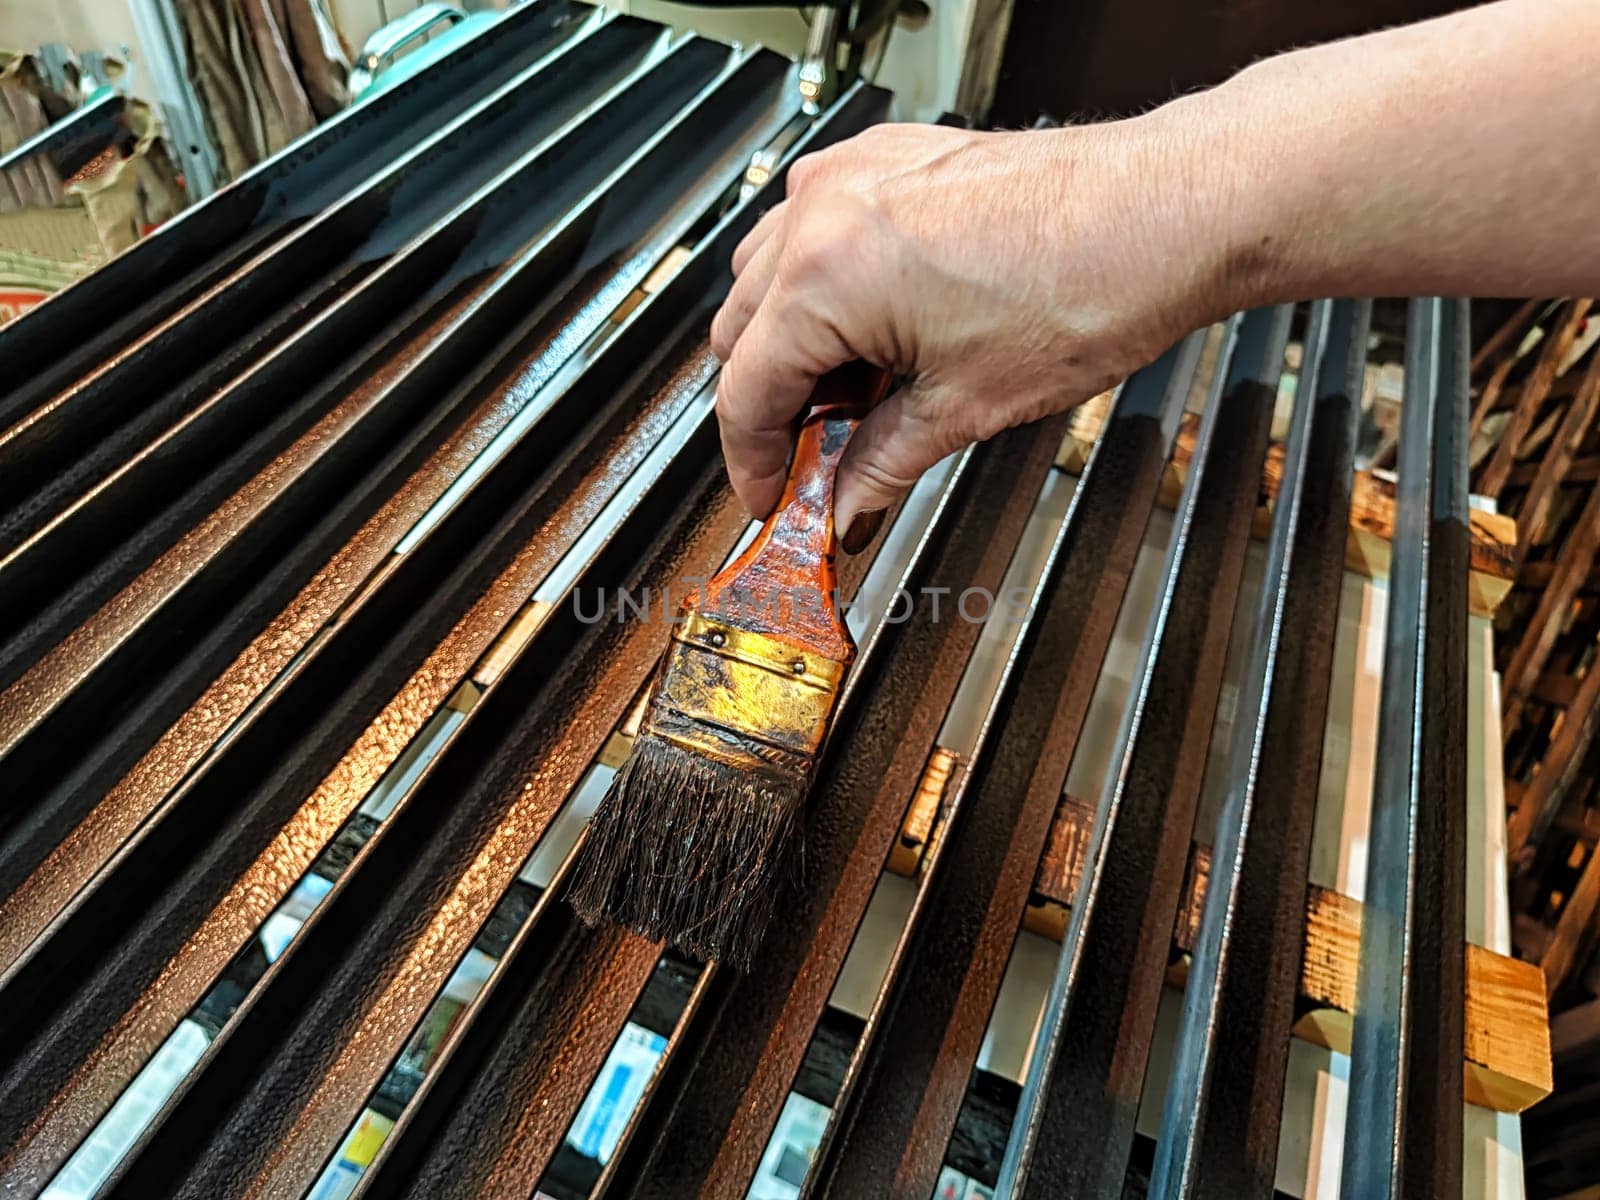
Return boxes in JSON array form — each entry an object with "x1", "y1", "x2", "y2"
[{"x1": 0, "y1": 88, "x2": 885, "y2": 1200}]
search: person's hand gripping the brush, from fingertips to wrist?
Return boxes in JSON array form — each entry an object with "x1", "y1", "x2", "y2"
[{"x1": 712, "y1": 110, "x2": 1232, "y2": 552}]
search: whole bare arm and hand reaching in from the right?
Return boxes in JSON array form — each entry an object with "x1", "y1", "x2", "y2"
[{"x1": 712, "y1": 0, "x2": 1600, "y2": 549}]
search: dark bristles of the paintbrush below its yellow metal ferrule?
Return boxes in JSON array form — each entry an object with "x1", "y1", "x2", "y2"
[{"x1": 570, "y1": 731, "x2": 808, "y2": 971}]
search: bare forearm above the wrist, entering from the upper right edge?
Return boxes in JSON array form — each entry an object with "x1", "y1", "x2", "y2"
[{"x1": 1139, "y1": 0, "x2": 1600, "y2": 315}]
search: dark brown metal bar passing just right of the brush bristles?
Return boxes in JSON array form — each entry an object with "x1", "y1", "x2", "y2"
[{"x1": 598, "y1": 418, "x2": 1064, "y2": 1197}]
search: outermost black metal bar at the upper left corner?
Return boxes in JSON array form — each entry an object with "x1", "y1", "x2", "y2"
[{"x1": 0, "y1": 0, "x2": 594, "y2": 409}]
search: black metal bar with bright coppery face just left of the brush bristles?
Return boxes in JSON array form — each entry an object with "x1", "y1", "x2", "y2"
[{"x1": 95, "y1": 421, "x2": 744, "y2": 1200}]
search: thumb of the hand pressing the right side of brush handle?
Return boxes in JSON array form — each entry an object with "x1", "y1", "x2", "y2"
[{"x1": 834, "y1": 382, "x2": 958, "y2": 554}]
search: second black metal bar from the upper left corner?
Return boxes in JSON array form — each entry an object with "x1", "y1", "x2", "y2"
[{"x1": 0, "y1": 19, "x2": 668, "y2": 555}]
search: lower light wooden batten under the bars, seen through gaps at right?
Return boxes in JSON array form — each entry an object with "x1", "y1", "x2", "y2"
[{"x1": 890, "y1": 800, "x2": 1555, "y2": 1112}]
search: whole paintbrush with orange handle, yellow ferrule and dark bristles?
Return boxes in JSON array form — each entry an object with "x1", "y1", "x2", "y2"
[{"x1": 571, "y1": 363, "x2": 890, "y2": 970}]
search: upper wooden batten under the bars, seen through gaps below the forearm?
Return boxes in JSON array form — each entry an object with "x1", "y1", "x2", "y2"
[{"x1": 1056, "y1": 412, "x2": 1517, "y2": 616}]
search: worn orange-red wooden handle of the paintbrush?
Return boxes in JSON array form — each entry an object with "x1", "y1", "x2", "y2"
[{"x1": 706, "y1": 362, "x2": 890, "y2": 662}]
